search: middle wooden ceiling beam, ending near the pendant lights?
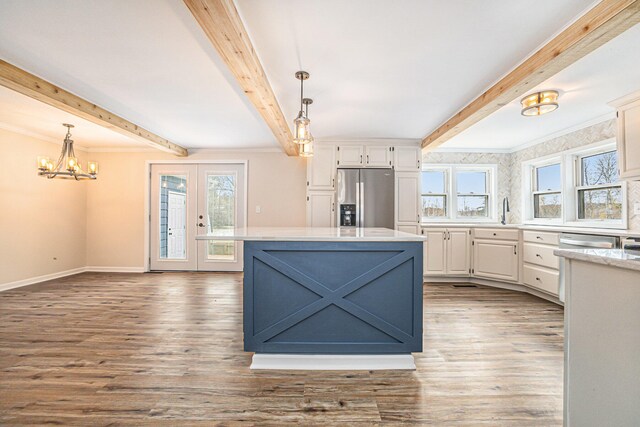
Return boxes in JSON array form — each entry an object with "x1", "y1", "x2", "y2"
[{"x1": 184, "y1": 0, "x2": 298, "y2": 156}]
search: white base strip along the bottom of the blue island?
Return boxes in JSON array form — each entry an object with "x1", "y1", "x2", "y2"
[{"x1": 251, "y1": 353, "x2": 416, "y2": 371}]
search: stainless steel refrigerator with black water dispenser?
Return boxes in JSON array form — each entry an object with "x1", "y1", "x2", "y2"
[{"x1": 336, "y1": 169, "x2": 395, "y2": 229}]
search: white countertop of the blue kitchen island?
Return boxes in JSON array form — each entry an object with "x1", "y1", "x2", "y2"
[{"x1": 196, "y1": 227, "x2": 427, "y2": 242}]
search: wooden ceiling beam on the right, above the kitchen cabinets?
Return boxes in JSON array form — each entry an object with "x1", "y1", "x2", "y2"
[{"x1": 422, "y1": 0, "x2": 640, "y2": 149}]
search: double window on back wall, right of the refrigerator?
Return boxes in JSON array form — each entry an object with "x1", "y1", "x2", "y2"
[{"x1": 422, "y1": 165, "x2": 496, "y2": 221}]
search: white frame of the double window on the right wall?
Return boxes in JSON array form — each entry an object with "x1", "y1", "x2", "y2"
[{"x1": 522, "y1": 138, "x2": 628, "y2": 230}]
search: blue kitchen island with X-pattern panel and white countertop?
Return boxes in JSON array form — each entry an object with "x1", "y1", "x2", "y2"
[{"x1": 198, "y1": 227, "x2": 424, "y2": 369}]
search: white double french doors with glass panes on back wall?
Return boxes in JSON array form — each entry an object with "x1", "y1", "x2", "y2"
[{"x1": 149, "y1": 163, "x2": 246, "y2": 271}]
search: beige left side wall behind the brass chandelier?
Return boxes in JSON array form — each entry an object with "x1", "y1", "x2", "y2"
[{"x1": 0, "y1": 129, "x2": 87, "y2": 285}]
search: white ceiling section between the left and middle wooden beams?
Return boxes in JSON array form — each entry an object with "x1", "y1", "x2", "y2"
[{"x1": 0, "y1": 0, "x2": 278, "y2": 148}]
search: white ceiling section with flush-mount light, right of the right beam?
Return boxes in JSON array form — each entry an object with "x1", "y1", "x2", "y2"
[{"x1": 441, "y1": 25, "x2": 640, "y2": 151}]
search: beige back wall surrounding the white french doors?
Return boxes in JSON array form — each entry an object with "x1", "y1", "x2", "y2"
[{"x1": 87, "y1": 151, "x2": 306, "y2": 268}]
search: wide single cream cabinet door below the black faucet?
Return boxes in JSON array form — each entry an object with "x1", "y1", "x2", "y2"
[{"x1": 473, "y1": 240, "x2": 518, "y2": 282}]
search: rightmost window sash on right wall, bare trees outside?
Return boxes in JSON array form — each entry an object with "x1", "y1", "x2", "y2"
[{"x1": 576, "y1": 150, "x2": 623, "y2": 220}]
